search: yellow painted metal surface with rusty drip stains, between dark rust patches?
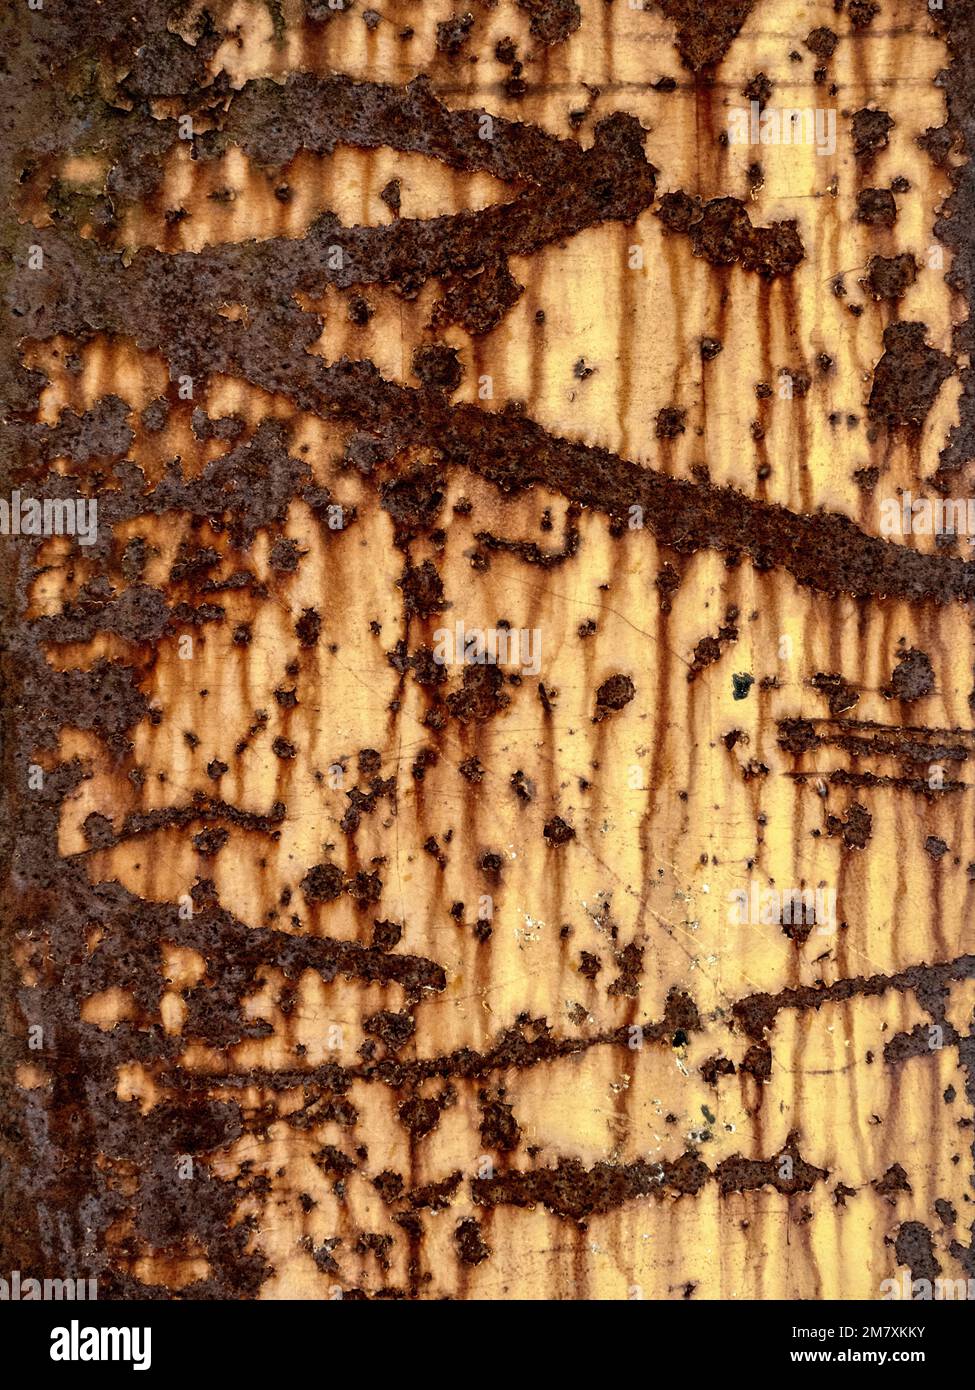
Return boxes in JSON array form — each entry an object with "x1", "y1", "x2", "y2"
[{"x1": 3, "y1": 0, "x2": 975, "y2": 1300}]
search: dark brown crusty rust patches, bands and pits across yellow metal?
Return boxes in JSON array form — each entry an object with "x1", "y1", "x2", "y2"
[{"x1": 3, "y1": 0, "x2": 975, "y2": 1297}]
